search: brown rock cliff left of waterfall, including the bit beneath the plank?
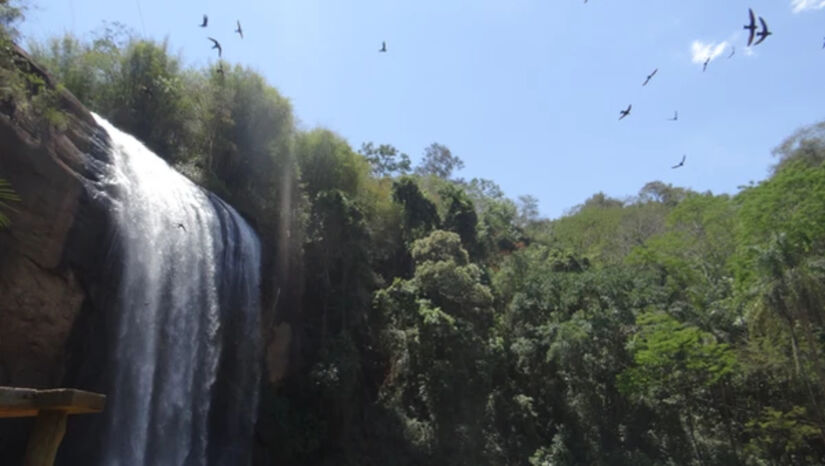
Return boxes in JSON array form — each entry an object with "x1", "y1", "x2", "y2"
[{"x1": 0, "y1": 43, "x2": 116, "y2": 464}]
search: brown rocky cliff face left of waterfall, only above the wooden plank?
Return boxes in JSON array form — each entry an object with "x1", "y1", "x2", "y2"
[{"x1": 0, "y1": 44, "x2": 113, "y2": 387}]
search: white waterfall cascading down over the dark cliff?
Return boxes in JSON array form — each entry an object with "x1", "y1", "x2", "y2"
[{"x1": 94, "y1": 115, "x2": 261, "y2": 466}]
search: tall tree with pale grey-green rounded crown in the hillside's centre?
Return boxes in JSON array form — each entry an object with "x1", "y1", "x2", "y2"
[{"x1": 374, "y1": 230, "x2": 493, "y2": 464}]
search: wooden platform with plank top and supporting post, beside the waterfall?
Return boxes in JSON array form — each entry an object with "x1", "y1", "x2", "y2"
[{"x1": 0, "y1": 387, "x2": 106, "y2": 466}]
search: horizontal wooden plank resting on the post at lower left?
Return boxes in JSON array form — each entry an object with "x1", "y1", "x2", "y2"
[{"x1": 0, "y1": 387, "x2": 106, "y2": 418}]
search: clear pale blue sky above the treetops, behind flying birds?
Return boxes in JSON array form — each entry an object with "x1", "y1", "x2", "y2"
[{"x1": 20, "y1": 0, "x2": 825, "y2": 218}]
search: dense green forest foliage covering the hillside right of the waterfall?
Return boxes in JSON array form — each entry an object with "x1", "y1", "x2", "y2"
[{"x1": 17, "y1": 25, "x2": 825, "y2": 465}]
